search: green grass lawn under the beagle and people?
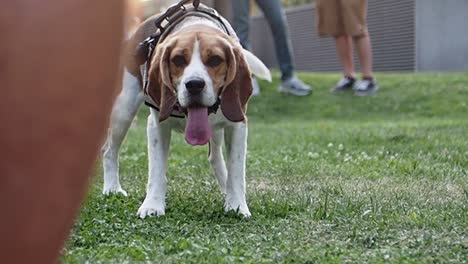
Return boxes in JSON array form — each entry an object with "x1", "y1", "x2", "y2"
[{"x1": 62, "y1": 74, "x2": 468, "y2": 263}]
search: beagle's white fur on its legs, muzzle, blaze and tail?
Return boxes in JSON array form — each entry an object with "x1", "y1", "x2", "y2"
[{"x1": 103, "y1": 13, "x2": 271, "y2": 218}]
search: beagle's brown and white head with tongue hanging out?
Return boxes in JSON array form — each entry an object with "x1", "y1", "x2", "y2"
[{"x1": 147, "y1": 25, "x2": 268, "y2": 145}]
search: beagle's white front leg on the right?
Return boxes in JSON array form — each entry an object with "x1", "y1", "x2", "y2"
[{"x1": 225, "y1": 122, "x2": 250, "y2": 217}]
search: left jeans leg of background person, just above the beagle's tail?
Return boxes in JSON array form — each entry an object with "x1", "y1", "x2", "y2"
[{"x1": 231, "y1": 0, "x2": 250, "y2": 49}]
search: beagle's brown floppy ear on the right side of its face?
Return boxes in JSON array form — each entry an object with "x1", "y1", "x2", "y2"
[{"x1": 221, "y1": 43, "x2": 253, "y2": 122}]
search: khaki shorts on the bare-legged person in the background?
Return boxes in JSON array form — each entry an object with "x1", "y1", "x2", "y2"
[{"x1": 316, "y1": 0, "x2": 367, "y2": 37}]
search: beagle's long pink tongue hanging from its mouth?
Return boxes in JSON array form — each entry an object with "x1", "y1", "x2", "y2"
[{"x1": 185, "y1": 107, "x2": 211, "y2": 146}]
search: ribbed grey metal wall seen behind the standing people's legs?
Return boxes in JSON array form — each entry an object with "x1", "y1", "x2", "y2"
[{"x1": 251, "y1": 0, "x2": 416, "y2": 72}]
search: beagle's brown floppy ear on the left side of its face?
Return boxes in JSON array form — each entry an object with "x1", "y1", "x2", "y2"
[{"x1": 146, "y1": 39, "x2": 177, "y2": 122}]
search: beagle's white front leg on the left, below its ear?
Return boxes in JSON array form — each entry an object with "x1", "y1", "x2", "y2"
[{"x1": 137, "y1": 110, "x2": 171, "y2": 218}]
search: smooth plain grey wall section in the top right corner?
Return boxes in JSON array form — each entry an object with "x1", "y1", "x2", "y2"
[{"x1": 416, "y1": 0, "x2": 468, "y2": 71}]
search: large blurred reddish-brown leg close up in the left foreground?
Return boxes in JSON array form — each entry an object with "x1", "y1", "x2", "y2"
[{"x1": 0, "y1": 0, "x2": 123, "y2": 264}]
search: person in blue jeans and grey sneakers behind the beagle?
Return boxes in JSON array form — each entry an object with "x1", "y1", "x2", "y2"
[{"x1": 231, "y1": 0, "x2": 312, "y2": 96}]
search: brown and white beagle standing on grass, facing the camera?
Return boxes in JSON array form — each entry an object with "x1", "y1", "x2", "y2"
[{"x1": 103, "y1": 5, "x2": 271, "y2": 218}]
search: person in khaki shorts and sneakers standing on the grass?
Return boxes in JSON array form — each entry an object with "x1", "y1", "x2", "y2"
[{"x1": 316, "y1": 0, "x2": 379, "y2": 96}]
